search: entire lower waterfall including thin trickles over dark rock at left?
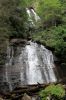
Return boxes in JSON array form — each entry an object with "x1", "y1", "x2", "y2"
[{"x1": 0, "y1": 41, "x2": 57, "y2": 91}]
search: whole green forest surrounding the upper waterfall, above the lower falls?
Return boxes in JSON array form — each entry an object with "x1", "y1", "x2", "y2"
[{"x1": 0, "y1": 0, "x2": 66, "y2": 66}]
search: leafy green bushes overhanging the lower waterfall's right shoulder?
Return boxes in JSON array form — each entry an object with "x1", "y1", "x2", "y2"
[{"x1": 32, "y1": 26, "x2": 66, "y2": 56}]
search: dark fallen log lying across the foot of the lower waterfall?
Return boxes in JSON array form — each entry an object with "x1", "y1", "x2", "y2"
[{"x1": 1, "y1": 80, "x2": 66, "y2": 98}]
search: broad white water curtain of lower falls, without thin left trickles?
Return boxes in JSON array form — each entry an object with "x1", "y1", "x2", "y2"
[{"x1": 26, "y1": 42, "x2": 56, "y2": 84}]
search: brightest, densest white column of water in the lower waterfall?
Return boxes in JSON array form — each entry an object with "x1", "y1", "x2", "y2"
[{"x1": 26, "y1": 43, "x2": 43, "y2": 84}]
